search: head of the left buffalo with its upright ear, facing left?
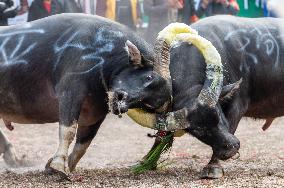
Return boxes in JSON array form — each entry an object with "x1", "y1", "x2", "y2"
[{"x1": 108, "y1": 41, "x2": 171, "y2": 115}]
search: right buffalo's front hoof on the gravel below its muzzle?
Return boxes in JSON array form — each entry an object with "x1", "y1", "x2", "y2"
[{"x1": 201, "y1": 164, "x2": 224, "y2": 179}]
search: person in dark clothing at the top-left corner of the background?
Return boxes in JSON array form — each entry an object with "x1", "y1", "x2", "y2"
[{"x1": 0, "y1": 0, "x2": 18, "y2": 26}]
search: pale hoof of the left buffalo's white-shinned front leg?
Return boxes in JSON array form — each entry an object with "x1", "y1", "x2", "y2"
[{"x1": 45, "y1": 156, "x2": 70, "y2": 181}]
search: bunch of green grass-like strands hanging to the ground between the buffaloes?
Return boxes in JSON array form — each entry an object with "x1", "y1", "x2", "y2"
[{"x1": 131, "y1": 133, "x2": 174, "y2": 174}]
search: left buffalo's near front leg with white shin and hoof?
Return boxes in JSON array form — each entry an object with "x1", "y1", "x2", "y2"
[{"x1": 46, "y1": 86, "x2": 85, "y2": 176}]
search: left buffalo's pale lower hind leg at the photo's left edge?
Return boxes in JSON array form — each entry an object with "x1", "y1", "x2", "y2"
[{"x1": 0, "y1": 130, "x2": 19, "y2": 167}]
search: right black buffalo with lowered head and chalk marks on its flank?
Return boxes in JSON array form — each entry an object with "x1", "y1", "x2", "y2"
[{"x1": 110, "y1": 16, "x2": 284, "y2": 178}]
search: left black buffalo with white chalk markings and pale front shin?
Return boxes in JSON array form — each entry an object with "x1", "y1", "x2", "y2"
[{"x1": 0, "y1": 14, "x2": 170, "y2": 174}]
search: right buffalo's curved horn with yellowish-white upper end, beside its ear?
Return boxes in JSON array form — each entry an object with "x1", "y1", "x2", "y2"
[{"x1": 175, "y1": 33, "x2": 223, "y2": 107}]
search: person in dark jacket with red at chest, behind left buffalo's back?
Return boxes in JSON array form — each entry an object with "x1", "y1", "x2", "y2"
[{"x1": 28, "y1": 0, "x2": 83, "y2": 22}]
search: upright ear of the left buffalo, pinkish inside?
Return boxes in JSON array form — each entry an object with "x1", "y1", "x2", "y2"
[{"x1": 125, "y1": 40, "x2": 143, "y2": 67}]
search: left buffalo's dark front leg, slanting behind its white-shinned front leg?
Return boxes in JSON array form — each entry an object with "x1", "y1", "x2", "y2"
[{"x1": 68, "y1": 117, "x2": 105, "y2": 172}]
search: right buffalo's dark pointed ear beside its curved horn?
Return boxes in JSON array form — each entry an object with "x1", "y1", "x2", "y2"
[{"x1": 219, "y1": 78, "x2": 243, "y2": 102}]
